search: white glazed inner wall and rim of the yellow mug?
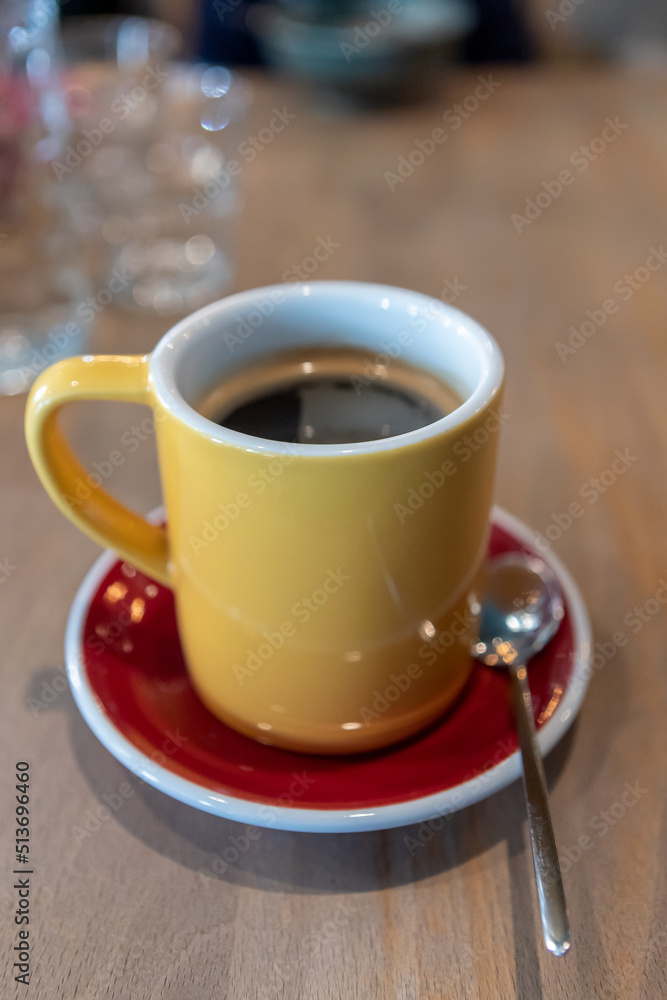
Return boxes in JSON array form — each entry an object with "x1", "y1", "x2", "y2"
[{"x1": 151, "y1": 281, "x2": 503, "y2": 452}]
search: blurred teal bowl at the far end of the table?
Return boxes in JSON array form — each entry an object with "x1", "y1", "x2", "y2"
[{"x1": 248, "y1": 0, "x2": 477, "y2": 104}]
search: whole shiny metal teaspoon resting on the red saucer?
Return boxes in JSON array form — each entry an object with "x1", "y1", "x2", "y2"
[{"x1": 472, "y1": 552, "x2": 570, "y2": 955}]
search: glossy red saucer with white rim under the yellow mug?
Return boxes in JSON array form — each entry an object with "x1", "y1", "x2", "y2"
[{"x1": 67, "y1": 511, "x2": 587, "y2": 829}]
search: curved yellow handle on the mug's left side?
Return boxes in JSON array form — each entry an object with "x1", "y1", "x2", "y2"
[{"x1": 25, "y1": 355, "x2": 170, "y2": 586}]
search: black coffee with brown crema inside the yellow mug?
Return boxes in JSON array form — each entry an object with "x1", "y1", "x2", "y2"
[{"x1": 197, "y1": 347, "x2": 462, "y2": 444}]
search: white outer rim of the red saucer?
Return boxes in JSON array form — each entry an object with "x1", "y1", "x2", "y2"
[{"x1": 65, "y1": 507, "x2": 591, "y2": 833}]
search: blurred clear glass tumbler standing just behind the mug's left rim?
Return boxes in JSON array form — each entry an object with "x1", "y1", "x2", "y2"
[{"x1": 102, "y1": 64, "x2": 249, "y2": 316}]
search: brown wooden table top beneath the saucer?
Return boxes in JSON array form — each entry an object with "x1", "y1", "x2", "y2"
[{"x1": 0, "y1": 68, "x2": 667, "y2": 1000}]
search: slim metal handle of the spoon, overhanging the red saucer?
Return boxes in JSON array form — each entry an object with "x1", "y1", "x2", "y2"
[{"x1": 510, "y1": 663, "x2": 570, "y2": 955}]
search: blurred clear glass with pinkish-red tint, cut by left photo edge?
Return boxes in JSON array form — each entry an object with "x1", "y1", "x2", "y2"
[{"x1": 0, "y1": 0, "x2": 90, "y2": 395}]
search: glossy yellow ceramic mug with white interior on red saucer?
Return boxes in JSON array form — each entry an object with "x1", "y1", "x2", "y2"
[{"x1": 26, "y1": 281, "x2": 503, "y2": 753}]
